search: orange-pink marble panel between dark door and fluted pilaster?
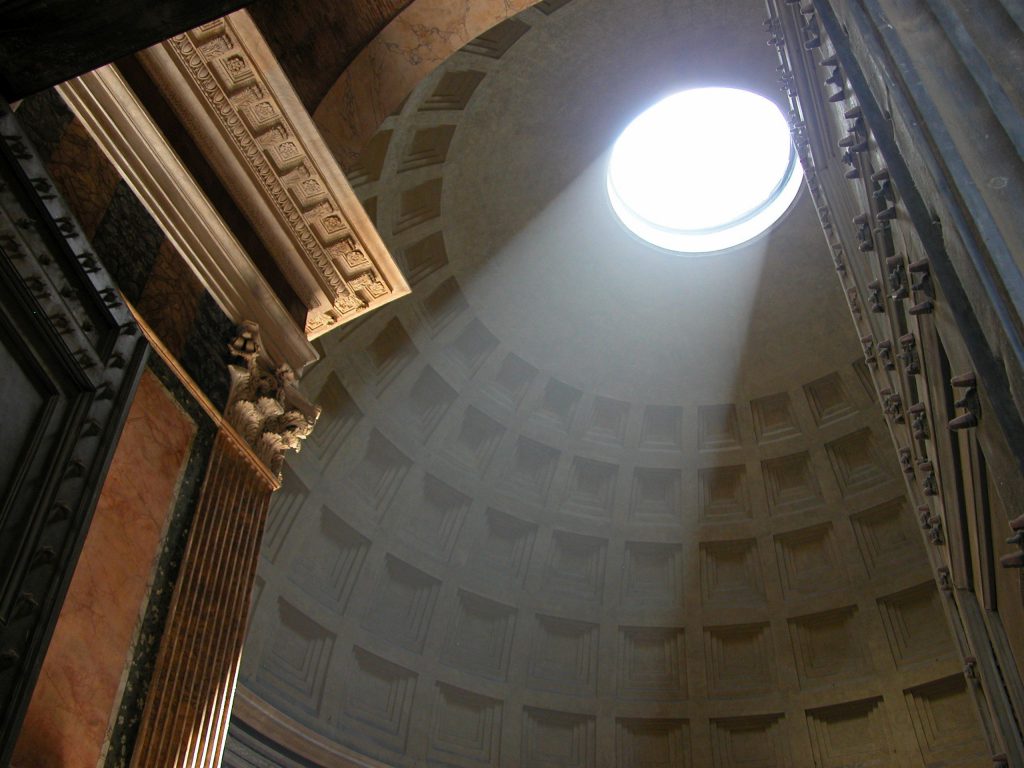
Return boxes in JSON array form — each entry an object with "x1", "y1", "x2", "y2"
[{"x1": 11, "y1": 371, "x2": 196, "y2": 768}]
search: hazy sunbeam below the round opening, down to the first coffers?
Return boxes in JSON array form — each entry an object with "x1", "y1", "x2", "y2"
[{"x1": 451, "y1": 154, "x2": 774, "y2": 403}]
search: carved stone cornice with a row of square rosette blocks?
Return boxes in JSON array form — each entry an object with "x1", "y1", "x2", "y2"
[{"x1": 141, "y1": 11, "x2": 409, "y2": 339}]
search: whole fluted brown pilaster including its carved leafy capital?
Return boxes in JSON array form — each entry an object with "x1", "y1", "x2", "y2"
[{"x1": 131, "y1": 324, "x2": 319, "y2": 768}]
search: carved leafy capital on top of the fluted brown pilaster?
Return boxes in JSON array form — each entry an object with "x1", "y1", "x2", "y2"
[{"x1": 224, "y1": 323, "x2": 321, "y2": 477}]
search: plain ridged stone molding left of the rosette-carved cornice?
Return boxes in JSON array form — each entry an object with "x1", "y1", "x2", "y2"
[{"x1": 57, "y1": 67, "x2": 317, "y2": 372}]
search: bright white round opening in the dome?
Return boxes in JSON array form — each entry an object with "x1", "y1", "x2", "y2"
[{"x1": 608, "y1": 88, "x2": 803, "y2": 253}]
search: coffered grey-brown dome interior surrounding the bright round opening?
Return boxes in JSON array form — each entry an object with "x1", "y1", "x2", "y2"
[{"x1": 225, "y1": 0, "x2": 983, "y2": 766}]
